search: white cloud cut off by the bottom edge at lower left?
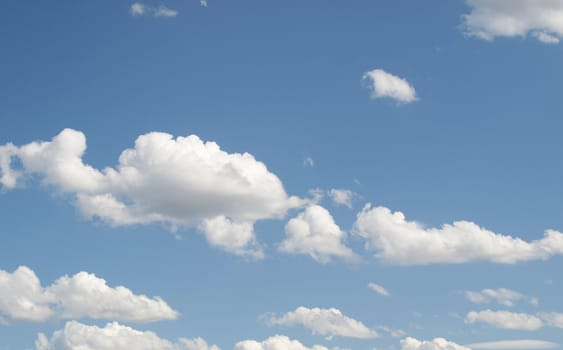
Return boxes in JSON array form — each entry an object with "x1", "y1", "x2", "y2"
[{"x1": 35, "y1": 321, "x2": 220, "y2": 350}]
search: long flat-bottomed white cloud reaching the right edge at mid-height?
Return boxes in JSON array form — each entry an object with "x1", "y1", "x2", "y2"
[{"x1": 353, "y1": 204, "x2": 563, "y2": 265}]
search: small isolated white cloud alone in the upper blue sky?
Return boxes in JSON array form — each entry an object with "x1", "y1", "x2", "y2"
[{"x1": 362, "y1": 69, "x2": 418, "y2": 103}]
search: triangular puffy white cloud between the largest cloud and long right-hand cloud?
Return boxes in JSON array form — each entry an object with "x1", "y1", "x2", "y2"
[{"x1": 280, "y1": 205, "x2": 359, "y2": 263}]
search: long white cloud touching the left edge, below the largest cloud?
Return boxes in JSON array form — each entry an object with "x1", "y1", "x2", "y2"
[{"x1": 0, "y1": 266, "x2": 178, "y2": 322}]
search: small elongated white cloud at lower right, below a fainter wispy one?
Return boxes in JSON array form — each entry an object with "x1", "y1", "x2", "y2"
[{"x1": 465, "y1": 310, "x2": 543, "y2": 331}]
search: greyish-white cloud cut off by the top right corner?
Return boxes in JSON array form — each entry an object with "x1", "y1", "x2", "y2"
[{"x1": 463, "y1": 0, "x2": 563, "y2": 44}]
